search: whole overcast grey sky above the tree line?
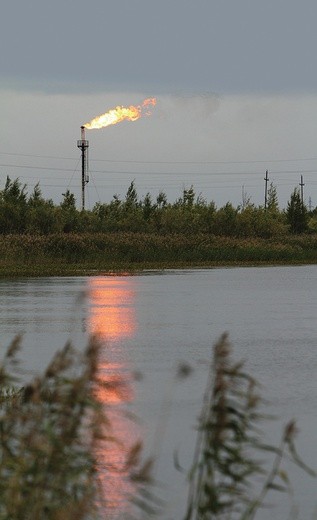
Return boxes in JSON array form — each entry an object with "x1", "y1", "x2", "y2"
[{"x1": 0, "y1": 0, "x2": 317, "y2": 208}]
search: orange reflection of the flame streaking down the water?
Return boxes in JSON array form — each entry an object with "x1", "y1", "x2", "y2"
[{"x1": 88, "y1": 277, "x2": 139, "y2": 520}]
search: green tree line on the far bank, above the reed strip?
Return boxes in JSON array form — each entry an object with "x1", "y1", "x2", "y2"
[{"x1": 0, "y1": 177, "x2": 317, "y2": 238}]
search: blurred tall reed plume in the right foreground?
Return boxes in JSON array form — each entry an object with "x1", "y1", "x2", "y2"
[{"x1": 185, "y1": 334, "x2": 316, "y2": 520}]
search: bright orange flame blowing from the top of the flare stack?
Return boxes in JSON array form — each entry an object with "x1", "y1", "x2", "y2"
[{"x1": 83, "y1": 98, "x2": 156, "y2": 130}]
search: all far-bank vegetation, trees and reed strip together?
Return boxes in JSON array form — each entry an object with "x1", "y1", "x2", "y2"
[{"x1": 0, "y1": 177, "x2": 317, "y2": 276}]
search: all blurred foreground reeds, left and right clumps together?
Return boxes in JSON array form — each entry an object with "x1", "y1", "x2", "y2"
[{"x1": 0, "y1": 334, "x2": 315, "y2": 520}]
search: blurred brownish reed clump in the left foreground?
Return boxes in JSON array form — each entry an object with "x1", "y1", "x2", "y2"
[{"x1": 0, "y1": 337, "x2": 153, "y2": 520}]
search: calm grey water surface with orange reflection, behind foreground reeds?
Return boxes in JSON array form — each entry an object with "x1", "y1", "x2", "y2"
[{"x1": 0, "y1": 266, "x2": 317, "y2": 520}]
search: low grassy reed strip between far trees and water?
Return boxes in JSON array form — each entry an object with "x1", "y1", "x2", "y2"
[{"x1": 0, "y1": 232, "x2": 317, "y2": 277}]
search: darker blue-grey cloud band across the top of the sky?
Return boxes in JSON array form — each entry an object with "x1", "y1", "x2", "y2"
[{"x1": 0, "y1": 0, "x2": 317, "y2": 93}]
